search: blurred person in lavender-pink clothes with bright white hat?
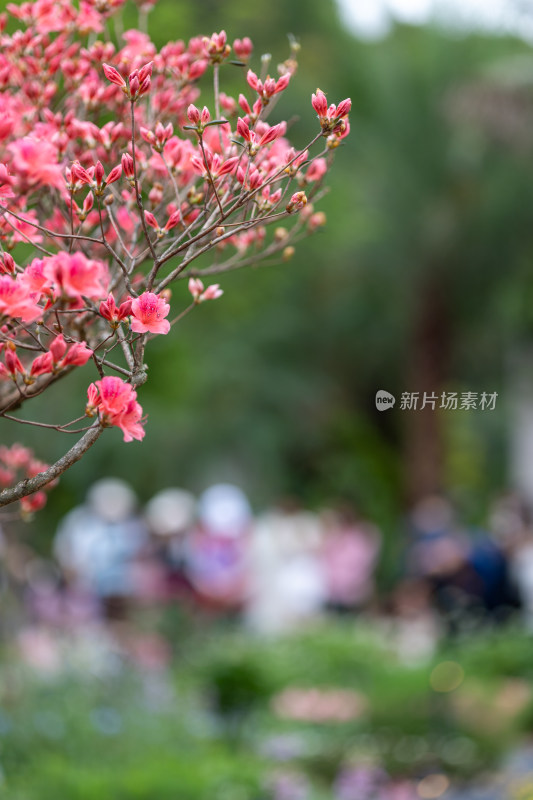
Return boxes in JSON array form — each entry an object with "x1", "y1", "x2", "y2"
[{"x1": 185, "y1": 483, "x2": 253, "y2": 611}]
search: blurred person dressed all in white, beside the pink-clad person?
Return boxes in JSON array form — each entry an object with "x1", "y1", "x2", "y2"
[{"x1": 246, "y1": 502, "x2": 327, "y2": 634}]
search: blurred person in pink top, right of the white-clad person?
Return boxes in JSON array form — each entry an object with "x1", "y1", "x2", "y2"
[{"x1": 321, "y1": 505, "x2": 381, "y2": 613}]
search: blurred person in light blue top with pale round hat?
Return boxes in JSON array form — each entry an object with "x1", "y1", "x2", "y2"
[{"x1": 54, "y1": 478, "x2": 148, "y2": 620}]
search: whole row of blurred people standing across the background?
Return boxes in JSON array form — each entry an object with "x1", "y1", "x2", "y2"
[{"x1": 0, "y1": 478, "x2": 533, "y2": 660}]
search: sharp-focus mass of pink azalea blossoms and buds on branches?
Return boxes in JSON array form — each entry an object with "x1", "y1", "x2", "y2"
[{"x1": 0, "y1": 0, "x2": 350, "y2": 505}]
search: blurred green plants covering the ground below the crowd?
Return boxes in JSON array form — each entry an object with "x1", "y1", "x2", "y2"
[{"x1": 0, "y1": 620, "x2": 533, "y2": 800}]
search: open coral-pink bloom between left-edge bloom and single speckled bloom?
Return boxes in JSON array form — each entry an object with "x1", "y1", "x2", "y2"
[{"x1": 43, "y1": 252, "x2": 107, "y2": 300}]
